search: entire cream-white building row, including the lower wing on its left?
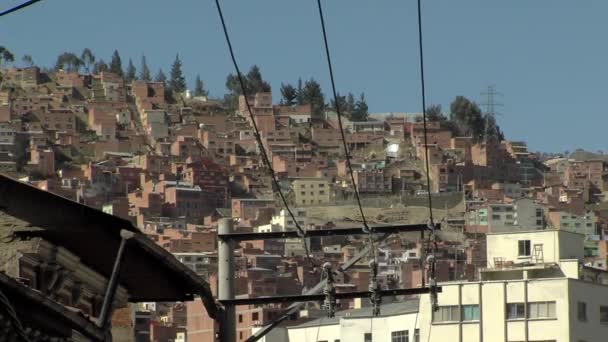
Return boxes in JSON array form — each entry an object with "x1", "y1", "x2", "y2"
[{"x1": 287, "y1": 230, "x2": 608, "y2": 342}]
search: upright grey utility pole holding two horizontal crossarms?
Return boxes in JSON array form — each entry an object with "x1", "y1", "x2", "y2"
[{"x1": 217, "y1": 218, "x2": 236, "y2": 342}]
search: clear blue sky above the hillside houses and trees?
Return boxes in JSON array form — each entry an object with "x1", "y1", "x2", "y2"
[{"x1": 0, "y1": 0, "x2": 608, "y2": 152}]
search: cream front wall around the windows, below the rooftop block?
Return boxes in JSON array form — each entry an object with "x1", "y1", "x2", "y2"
[{"x1": 419, "y1": 278, "x2": 572, "y2": 342}]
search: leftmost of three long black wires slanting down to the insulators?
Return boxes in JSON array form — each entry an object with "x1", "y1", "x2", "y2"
[{"x1": 215, "y1": 0, "x2": 318, "y2": 267}]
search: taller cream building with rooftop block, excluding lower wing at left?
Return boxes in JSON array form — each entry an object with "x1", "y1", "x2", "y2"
[{"x1": 420, "y1": 230, "x2": 608, "y2": 342}]
